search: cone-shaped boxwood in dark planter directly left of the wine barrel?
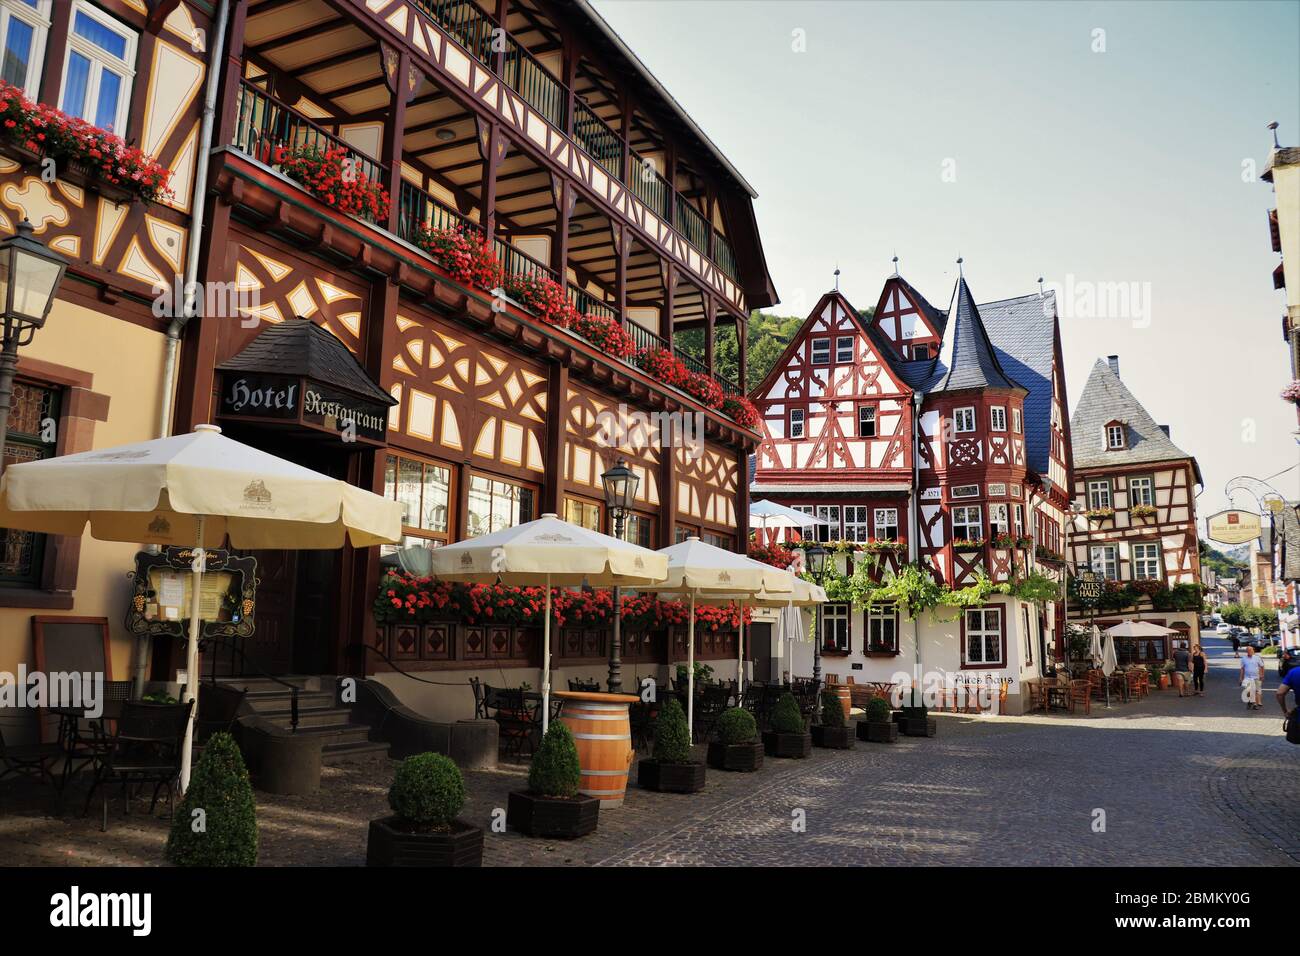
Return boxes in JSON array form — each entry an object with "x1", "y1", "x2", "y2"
[{"x1": 506, "y1": 721, "x2": 601, "y2": 839}]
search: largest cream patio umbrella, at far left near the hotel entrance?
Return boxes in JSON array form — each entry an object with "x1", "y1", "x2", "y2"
[{"x1": 0, "y1": 425, "x2": 402, "y2": 792}]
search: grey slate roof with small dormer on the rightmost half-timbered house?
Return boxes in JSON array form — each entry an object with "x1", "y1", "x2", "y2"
[{"x1": 1070, "y1": 359, "x2": 1201, "y2": 481}]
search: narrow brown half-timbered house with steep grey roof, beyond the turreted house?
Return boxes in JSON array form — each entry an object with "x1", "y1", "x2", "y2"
[{"x1": 1067, "y1": 355, "x2": 1203, "y2": 663}]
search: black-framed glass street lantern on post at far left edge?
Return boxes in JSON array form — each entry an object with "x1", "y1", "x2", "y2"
[{"x1": 0, "y1": 220, "x2": 68, "y2": 472}]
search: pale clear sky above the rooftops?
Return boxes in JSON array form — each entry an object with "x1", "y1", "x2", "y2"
[{"x1": 594, "y1": 0, "x2": 1300, "y2": 529}]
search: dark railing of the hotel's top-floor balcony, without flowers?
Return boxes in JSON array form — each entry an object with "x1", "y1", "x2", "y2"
[{"x1": 415, "y1": 0, "x2": 737, "y2": 291}]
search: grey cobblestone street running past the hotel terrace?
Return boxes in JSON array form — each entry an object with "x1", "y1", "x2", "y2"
[{"x1": 0, "y1": 639, "x2": 1300, "y2": 866}]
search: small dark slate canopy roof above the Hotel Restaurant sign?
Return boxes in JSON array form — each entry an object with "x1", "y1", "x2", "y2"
[{"x1": 217, "y1": 319, "x2": 398, "y2": 405}]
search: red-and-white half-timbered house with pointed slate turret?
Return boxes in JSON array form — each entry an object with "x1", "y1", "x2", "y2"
[{"x1": 751, "y1": 274, "x2": 1070, "y2": 709}]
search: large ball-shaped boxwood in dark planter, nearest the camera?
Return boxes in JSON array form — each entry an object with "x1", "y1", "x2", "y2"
[{"x1": 365, "y1": 753, "x2": 484, "y2": 866}]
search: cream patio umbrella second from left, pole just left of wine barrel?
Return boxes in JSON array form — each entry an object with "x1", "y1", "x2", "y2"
[{"x1": 432, "y1": 514, "x2": 668, "y2": 734}]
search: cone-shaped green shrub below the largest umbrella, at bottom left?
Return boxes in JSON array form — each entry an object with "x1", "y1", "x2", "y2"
[{"x1": 164, "y1": 732, "x2": 257, "y2": 866}]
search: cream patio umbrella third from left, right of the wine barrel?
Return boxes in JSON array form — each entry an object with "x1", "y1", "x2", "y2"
[{"x1": 655, "y1": 536, "x2": 794, "y2": 734}]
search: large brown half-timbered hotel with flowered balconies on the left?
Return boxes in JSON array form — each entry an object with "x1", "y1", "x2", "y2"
[{"x1": 0, "y1": 0, "x2": 776, "y2": 733}]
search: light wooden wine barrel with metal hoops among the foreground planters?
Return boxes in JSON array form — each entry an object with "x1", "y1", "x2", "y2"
[{"x1": 555, "y1": 691, "x2": 638, "y2": 809}]
